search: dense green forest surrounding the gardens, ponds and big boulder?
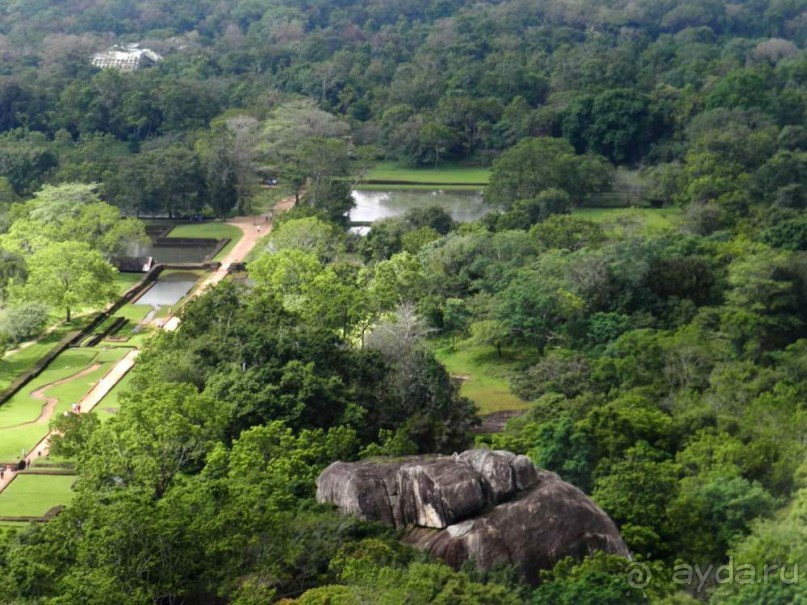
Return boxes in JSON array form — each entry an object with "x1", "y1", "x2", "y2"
[{"x1": 0, "y1": 0, "x2": 807, "y2": 605}]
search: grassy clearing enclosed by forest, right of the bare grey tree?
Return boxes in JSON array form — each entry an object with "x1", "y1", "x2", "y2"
[{"x1": 434, "y1": 340, "x2": 528, "y2": 415}]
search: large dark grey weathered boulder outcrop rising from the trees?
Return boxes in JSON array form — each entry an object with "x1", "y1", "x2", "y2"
[{"x1": 317, "y1": 450, "x2": 628, "y2": 582}]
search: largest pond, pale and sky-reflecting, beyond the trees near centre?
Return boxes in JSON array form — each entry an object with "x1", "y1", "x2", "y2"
[{"x1": 350, "y1": 190, "x2": 490, "y2": 223}]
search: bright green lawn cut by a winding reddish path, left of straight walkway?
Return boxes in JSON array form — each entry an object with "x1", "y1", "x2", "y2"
[{"x1": 0, "y1": 348, "x2": 128, "y2": 462}]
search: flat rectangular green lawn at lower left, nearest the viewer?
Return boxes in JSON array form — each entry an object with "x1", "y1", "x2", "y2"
[{"x1": 0, "y1": 475, "x2": 76, "y2": 517}]
